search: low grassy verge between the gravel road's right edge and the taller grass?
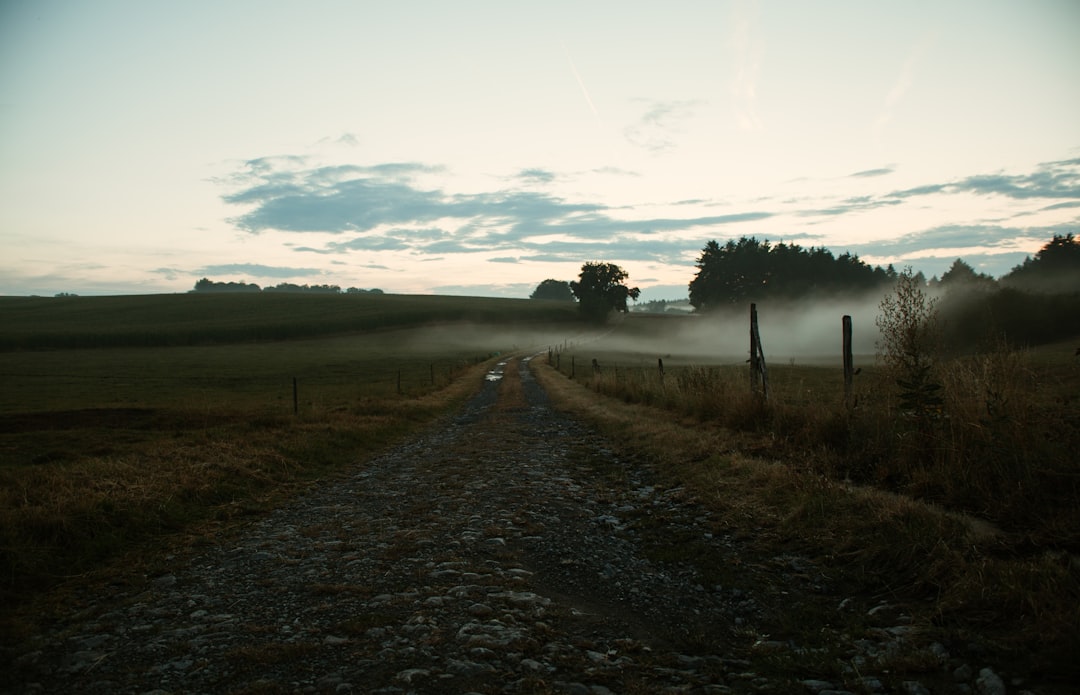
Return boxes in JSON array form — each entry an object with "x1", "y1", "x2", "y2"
[{"x1": 534, "y1": 357, "x2": 1080, "y2": 680}]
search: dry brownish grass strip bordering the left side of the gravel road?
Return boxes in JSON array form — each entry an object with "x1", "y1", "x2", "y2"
[{"x1": 0, "y1": 358, "x2": 494, "y2": 608}]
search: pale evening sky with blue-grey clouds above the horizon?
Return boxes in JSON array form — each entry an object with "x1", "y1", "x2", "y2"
[{"x1": 0, "y1": 0, "x2": 1080, "y2": 301}]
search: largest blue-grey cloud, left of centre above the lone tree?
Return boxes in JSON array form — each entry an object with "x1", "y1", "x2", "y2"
[{"x1": 222, "y1": 158, "x2": 773, "y2": 259}]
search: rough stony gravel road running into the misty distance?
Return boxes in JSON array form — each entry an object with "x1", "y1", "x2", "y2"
[{"x1": 0, "y1": 360, "x2": 1028, "y2": 695}]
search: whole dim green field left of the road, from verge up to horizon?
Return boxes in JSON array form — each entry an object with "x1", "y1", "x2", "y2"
[{"x1": 0, "y1": 294, "x2": 581, "y2": 605}]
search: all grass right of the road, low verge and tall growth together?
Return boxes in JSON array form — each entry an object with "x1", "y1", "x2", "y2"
[{"x1": 534, "y1": 344, "x2": 1080, "y2": 683}]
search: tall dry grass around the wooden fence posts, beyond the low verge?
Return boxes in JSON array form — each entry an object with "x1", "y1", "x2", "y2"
[{"x1": 561, "y1": 345, "x2": 1080, "y2": 551}]
